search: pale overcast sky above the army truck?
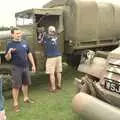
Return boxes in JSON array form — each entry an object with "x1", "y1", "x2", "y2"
[{"x1": 0, "y1": 0, "x2": 120, "y2": 26}]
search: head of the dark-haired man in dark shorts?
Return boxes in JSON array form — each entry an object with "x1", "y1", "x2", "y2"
[{"x1": 11, "y1": 28, "x2": 22, "y2": 40}]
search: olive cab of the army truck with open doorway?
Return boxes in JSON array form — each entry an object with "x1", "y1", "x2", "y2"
[{"x1": 15, "y1": 8, "x2": 64, "y2": 71}]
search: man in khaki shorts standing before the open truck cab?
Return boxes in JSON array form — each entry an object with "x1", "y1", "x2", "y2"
[{"x1": 39, "y1": 26, "x2": 62, "y2": 92}]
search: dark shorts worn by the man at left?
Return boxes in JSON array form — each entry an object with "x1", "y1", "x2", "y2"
[{"x1": 12, "y1": 66, "x2": 31, "y2": 88}]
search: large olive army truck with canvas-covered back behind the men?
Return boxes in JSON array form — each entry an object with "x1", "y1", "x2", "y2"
[{"x1": 0, "y1": 0, "x2": 120, "y2": 71}]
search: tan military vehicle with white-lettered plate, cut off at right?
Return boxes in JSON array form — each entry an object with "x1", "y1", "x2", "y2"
[{"x1": 73, "y1": 47, "x2": 120, "y2": 120}]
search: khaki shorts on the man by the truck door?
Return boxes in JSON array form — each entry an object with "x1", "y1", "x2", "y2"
[{"x1": 46, "y1": 56, "x2": 62, "y2": 74}]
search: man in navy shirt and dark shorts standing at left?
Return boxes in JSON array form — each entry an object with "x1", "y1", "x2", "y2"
[{"x1": 5, "y1": 28, "x2": 36, "y2": 112}]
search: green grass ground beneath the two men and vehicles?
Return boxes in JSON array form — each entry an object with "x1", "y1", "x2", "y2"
[{"x1": 5, "y1": 68, "x2": 79, "y2": 120}]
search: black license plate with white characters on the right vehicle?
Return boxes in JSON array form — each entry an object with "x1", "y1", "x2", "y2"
[{"x1": 105, "y1": 79, "x2": 120, "y2": 94}]
